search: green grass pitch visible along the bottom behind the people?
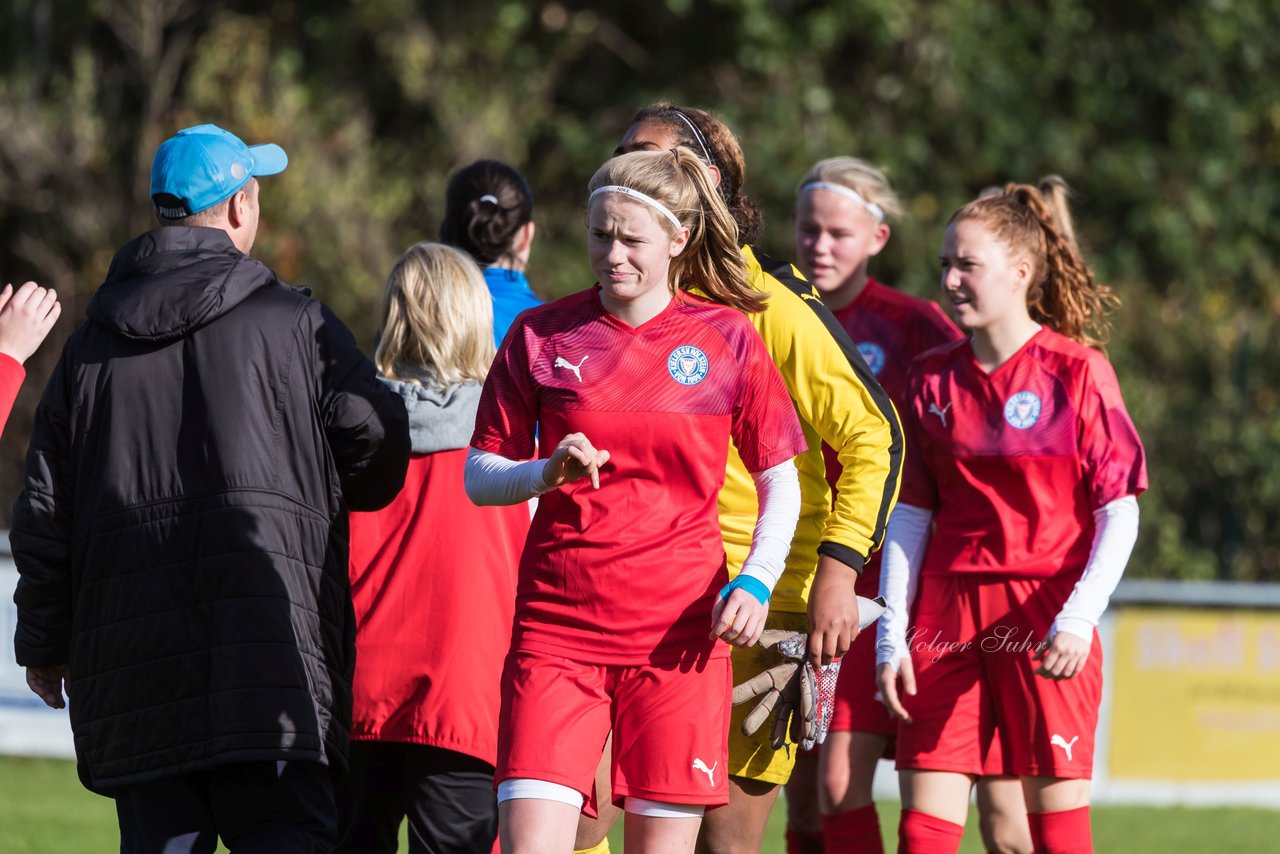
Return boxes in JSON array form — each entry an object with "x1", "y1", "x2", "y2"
[{"x1": 0, "y1": 757, "x2": 1280, "y2": 854}]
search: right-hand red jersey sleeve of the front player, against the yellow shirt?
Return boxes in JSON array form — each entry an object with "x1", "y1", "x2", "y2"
[{"x1": 730, "y1": 326, "x2": 809, "y2": 471}]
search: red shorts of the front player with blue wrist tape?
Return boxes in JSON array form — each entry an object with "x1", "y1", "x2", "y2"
[{"x1": 494, "y1": 652, "x2": 733, "y2": 816}]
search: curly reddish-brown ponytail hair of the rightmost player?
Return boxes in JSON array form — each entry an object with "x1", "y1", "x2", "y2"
[{"x1": 947, "y1": 175, "x2": 1120, "y2": 347}]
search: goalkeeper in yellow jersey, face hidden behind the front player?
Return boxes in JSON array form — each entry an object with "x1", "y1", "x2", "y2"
[{"x1": 579, "y1": 102, "x2": 902, "y2": 853}]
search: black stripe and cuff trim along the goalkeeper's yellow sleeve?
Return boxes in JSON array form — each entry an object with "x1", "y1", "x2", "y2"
[{"x1": 751, "y1": 246, "x2": 902, "y2": 563}]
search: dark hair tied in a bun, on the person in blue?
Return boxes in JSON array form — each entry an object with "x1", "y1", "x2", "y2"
[{"x1": 440, "y1": 160, "x2": 534, "y2": 266}]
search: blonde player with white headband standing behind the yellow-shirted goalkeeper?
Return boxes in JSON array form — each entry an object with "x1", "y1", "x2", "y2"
[{"x1": 787, "y1": 157, "x2": 1030, "y2": 854}]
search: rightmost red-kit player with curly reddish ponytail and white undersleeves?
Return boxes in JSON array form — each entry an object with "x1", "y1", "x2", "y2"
[{"x1": 877, "y1": 178, "x2": 1147, "y2": 854}]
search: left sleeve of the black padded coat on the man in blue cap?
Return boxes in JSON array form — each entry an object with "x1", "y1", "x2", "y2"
[{"x1": 9, "y1": 356, "x2": 73, "y2": 667}]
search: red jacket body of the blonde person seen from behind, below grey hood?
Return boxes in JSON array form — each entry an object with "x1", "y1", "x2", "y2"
[{"x1": 349, "y1": 449, "x2": 529, "y2": 764}]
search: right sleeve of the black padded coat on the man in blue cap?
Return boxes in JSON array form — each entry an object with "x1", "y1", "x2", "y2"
[{"x1": 310, "y1": 303, "x2": 410, "y2": 511}]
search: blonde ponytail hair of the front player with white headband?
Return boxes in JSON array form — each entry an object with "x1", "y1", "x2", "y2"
[{"x1": 588, "y1": 146, "x2": 765, "y2": 311}]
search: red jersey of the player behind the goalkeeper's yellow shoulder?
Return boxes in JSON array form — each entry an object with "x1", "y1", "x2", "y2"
[{"x1": 822, "y1": 278, "x2": 961, "y2": 597}]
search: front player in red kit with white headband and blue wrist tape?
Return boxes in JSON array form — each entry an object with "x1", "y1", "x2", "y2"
[{"x1": 466, "y1": 149, "x2": 805, "y2": 854}]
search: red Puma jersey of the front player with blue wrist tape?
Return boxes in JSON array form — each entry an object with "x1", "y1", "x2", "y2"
[{"x1": 471, "y1": 288, "x2": 805, "y2": 665}]
